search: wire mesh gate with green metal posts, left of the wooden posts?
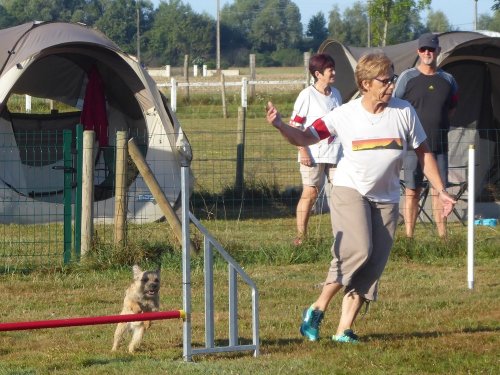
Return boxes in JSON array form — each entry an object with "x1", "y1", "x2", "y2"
[{"x1": 0, "y1": 126, "x2": 83, "y2": 270}]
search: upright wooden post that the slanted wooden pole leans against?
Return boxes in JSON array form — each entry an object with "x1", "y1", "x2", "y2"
[{"x1": 114, "y1": 131, "x2": 128, "y2": 246}]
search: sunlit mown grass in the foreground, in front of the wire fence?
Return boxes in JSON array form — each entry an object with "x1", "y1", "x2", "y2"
[{"x1": 0, "y1": 239, "x2": 500, "y2": 375}]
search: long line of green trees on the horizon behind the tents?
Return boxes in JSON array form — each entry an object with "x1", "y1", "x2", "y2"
[{"x1": 0, "y1": 0, "x2": 500, "y2": 68}]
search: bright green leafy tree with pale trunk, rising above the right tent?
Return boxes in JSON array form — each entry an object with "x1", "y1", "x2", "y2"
[{"x1": 368, "y1": 0, "x2": 431, "y2": 46}]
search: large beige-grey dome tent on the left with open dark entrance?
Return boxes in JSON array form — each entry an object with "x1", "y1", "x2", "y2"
[{"x1": 0, "y1": 22, "x2": 191, "y2": 223}]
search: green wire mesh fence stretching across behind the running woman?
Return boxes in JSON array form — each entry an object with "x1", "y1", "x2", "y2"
[{"x1": 0, "y1": 117, "x2": 500, "y2": 268}]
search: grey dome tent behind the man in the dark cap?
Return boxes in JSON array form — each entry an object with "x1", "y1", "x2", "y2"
[{"x1": 319, "y1": 31, "x2": 500, "y2": 203}]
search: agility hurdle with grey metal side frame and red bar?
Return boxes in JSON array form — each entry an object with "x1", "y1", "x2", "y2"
[{"x1": 0, "y1": 166, "x2": 259, "y2": 361}]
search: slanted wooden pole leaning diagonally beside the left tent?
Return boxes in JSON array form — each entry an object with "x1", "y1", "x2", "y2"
[{"x1": 128, "y1": 138, "x2": 195, "y2": 251}]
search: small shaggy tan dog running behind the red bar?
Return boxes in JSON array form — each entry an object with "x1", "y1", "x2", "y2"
[{"x1": 111, "y1": 265, "x2": 160, "y2": 353}]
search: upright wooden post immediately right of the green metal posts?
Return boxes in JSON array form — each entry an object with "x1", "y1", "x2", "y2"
[{"x1": 81, "y1": 130, "x2": 95, "y2": 256}]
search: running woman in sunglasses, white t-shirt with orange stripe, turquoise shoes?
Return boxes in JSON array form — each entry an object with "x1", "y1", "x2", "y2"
[{"x1": 267, "y1": 53, "x2": 456, "y2": 343}]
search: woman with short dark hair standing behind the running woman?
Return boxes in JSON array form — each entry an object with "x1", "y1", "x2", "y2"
[{"x1": 290, "y1": 53, "x2": 342, "y2": 246}]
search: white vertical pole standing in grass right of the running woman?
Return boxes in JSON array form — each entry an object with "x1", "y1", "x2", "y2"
[{"x1": 467, "y1": 145, "x2": 476, "y2": 289}]
